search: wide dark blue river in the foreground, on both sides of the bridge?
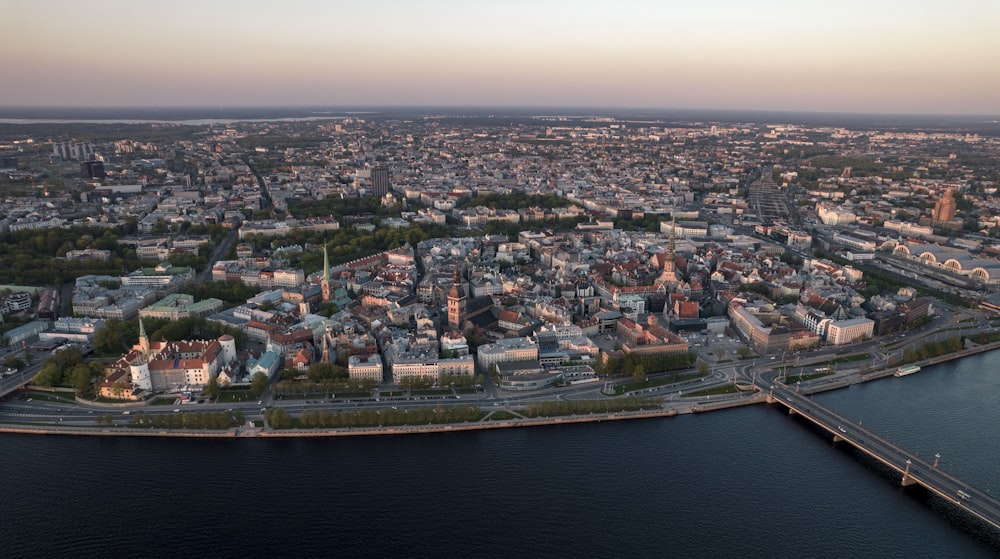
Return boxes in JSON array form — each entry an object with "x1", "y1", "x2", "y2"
[{"x1": 0, "y1": 352, "x2": 1000, "y2": 558}]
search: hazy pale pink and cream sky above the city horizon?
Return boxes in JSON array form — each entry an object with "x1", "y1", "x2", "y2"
[{"x1": 0, "y1": 0, "x2": 1000, "y2": 115}]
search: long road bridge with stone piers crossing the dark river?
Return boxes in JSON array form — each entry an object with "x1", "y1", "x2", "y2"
[{"x1": 765, "y1": 382, "x2": 1000, "y2": 529}]
